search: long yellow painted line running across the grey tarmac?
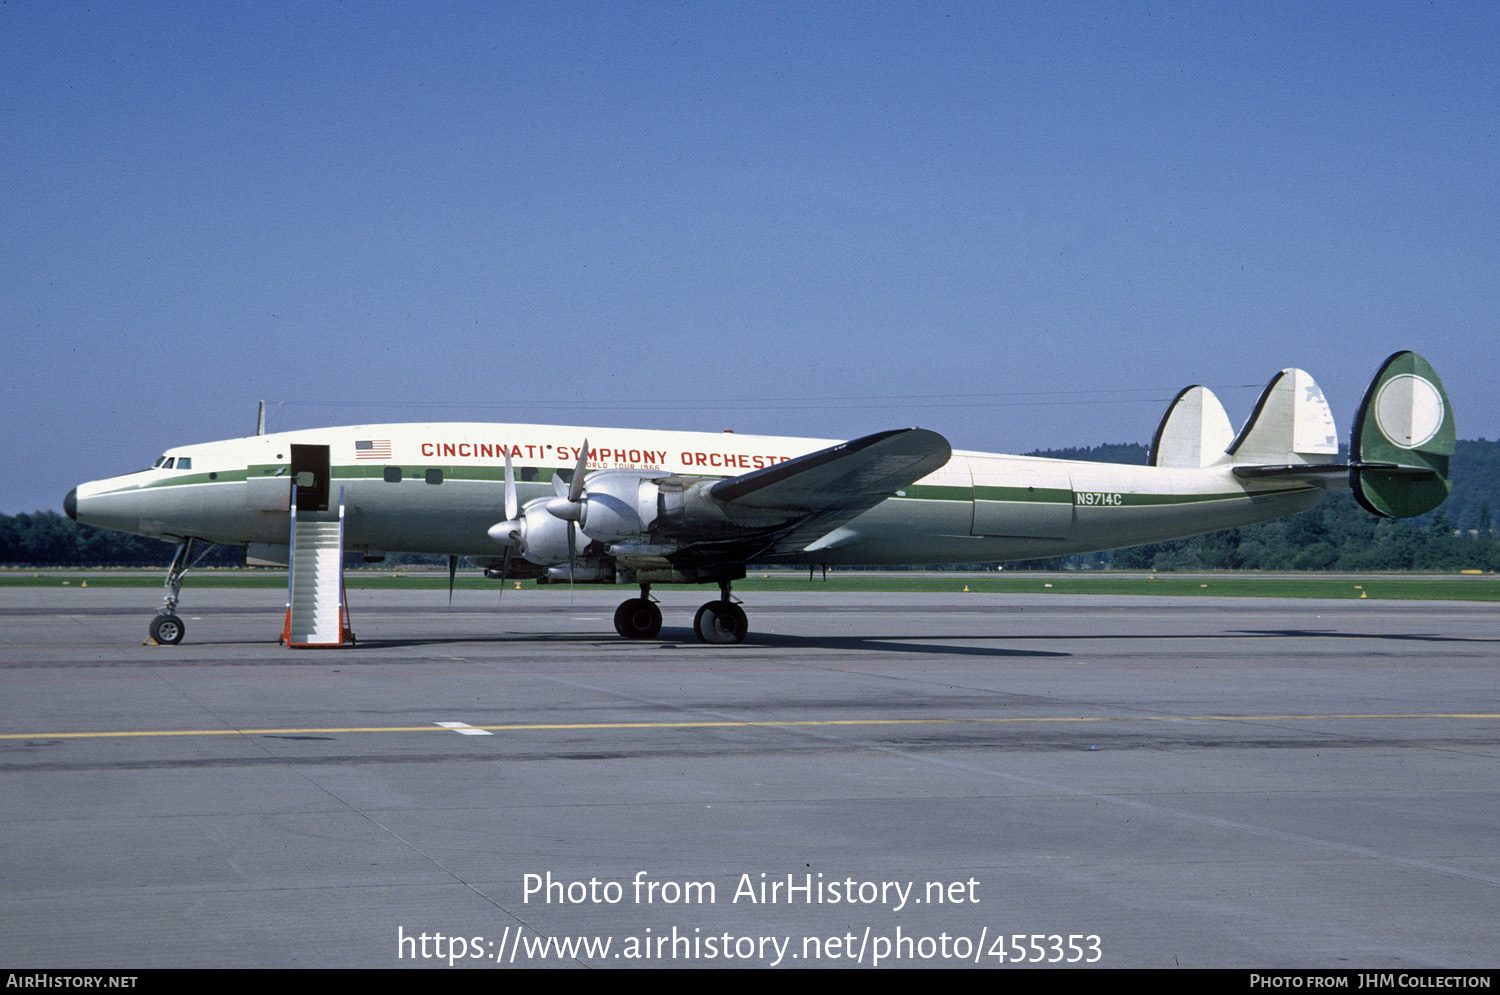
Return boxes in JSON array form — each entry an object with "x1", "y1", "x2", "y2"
[{"x1": 0, "y1": 711, "x2": 1500, "y2": 740}]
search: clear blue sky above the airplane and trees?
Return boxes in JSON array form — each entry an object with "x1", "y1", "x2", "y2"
[{"x1": 0, "y1": 0, "x2": 1500, "y2": 513}]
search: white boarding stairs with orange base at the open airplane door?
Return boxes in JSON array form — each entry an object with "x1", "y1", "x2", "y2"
[{"x1": 282, "y1": 488, "x2": 354, "y2": 648}]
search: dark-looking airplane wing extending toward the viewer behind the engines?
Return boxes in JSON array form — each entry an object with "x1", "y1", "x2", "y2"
[{"x1": 708, "y1": 428, "x2": 953, "y2": 555}]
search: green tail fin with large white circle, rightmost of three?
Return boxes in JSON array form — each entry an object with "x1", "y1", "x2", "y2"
[{"x1": 1349, "y1": 351, "x2": 1458, "y2": 518}]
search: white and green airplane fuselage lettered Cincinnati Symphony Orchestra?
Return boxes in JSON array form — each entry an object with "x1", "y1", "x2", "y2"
[{"x1": 69, "y1": 422, "x2": 1325, "y2": 566}]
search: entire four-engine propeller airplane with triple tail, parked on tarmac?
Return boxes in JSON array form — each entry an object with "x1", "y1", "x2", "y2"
[{"x1": 65, "y1": 353, "x2": 1457, "y2": 645}]
